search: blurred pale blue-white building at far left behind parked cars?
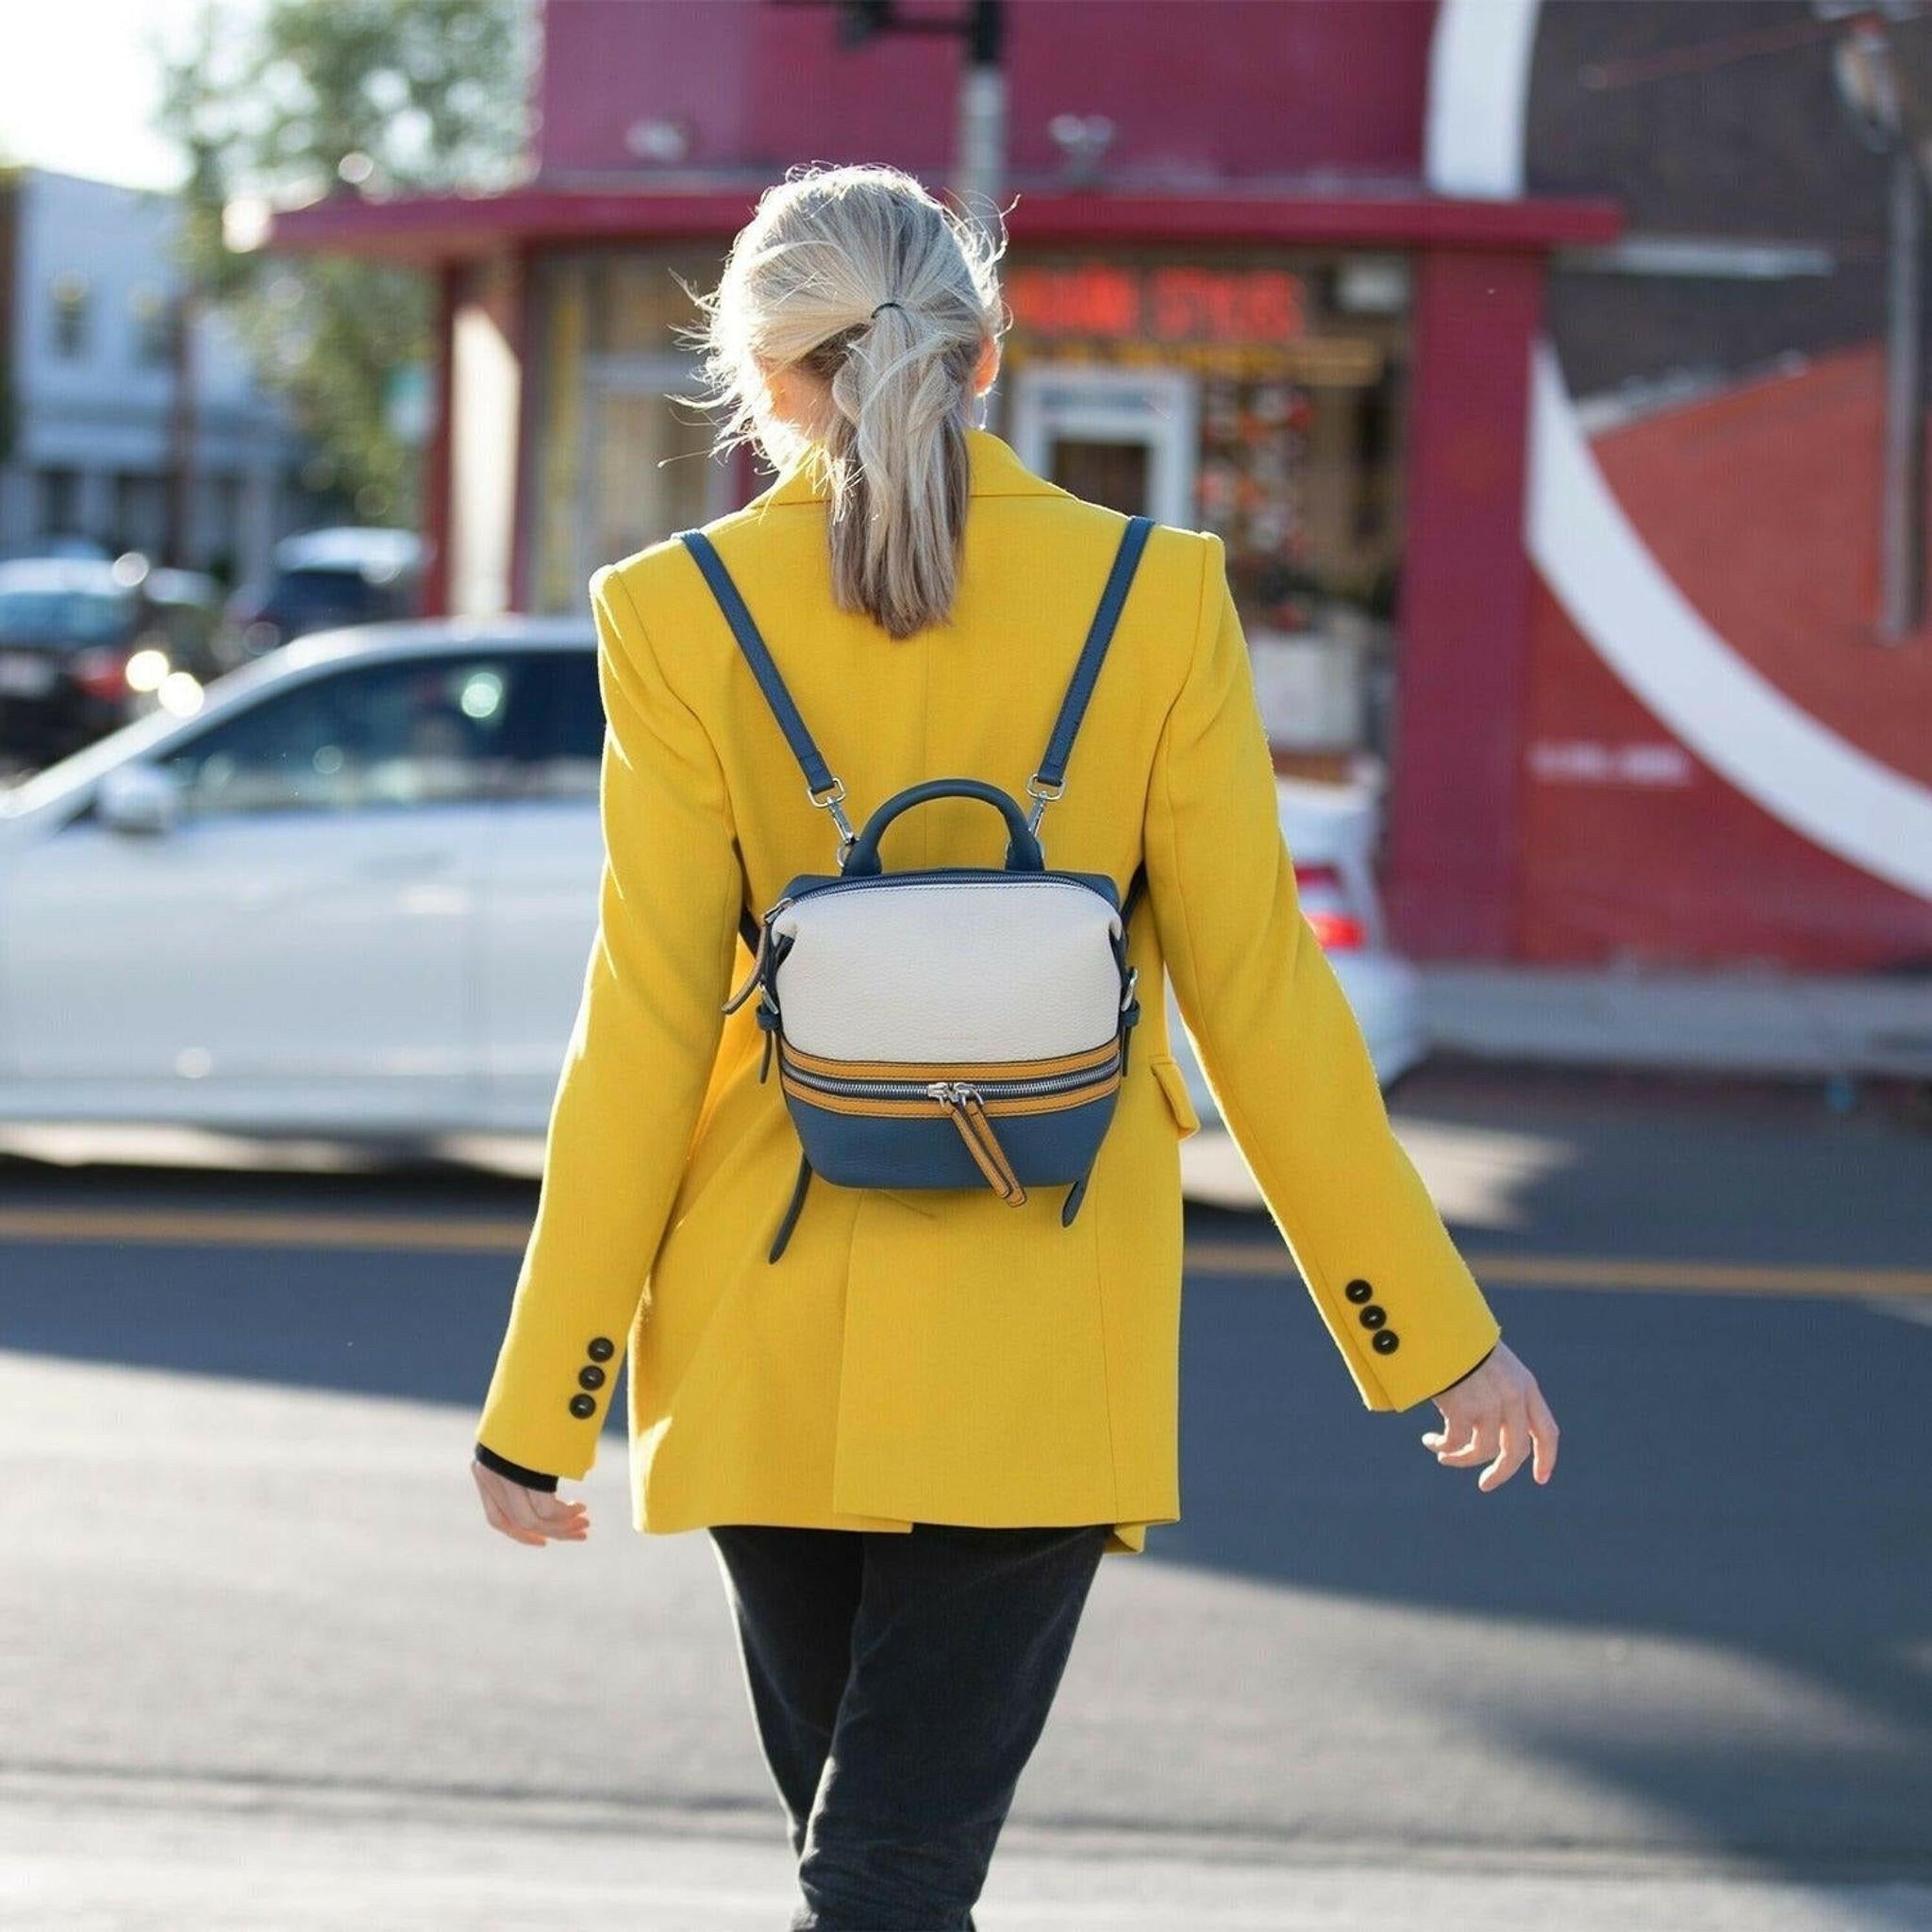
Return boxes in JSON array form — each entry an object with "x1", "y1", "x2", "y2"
[{"x1": 0, "y1": 168, "x2": 316, "y2": 581}]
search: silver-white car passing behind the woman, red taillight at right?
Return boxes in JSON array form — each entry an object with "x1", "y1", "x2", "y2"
[{"x1": 0, "y1": 618, "x2": 1422, "y2": 1145}]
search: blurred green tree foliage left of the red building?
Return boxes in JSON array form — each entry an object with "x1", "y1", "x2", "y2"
[{"x1": 157, "y1": 0, "x2": 537, "y2": 525}]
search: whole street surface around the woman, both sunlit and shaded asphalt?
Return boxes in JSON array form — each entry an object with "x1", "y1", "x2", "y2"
[{"x1": 0, "y1": 1073, "x2": 1932, "y2": 1932}]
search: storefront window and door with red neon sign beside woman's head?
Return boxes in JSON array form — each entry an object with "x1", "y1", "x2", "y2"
[{"x1": 990, "y1": 249, "x2": 1408, "y2": 774}]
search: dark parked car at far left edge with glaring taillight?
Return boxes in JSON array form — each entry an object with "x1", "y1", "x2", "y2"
[{"x1": 0, "y1": 553, "x2": 220, "y2": 763}]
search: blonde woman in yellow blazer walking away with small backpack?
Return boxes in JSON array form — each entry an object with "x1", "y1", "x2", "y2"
[{"x1": 474, "y1": 166, "x2": 1557, "y2": 1932}]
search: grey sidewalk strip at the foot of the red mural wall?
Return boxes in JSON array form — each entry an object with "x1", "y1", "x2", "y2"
[{"x1": 1418, "y1": 964, "x2": 1932, "y2": 1080}]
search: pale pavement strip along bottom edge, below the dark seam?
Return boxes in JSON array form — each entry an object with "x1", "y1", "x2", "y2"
[{"x1": 0, "y1": 1781, "x2": 1932, "y2": 1932}]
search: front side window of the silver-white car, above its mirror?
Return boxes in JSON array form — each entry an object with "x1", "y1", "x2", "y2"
[{"x1": 162, "y1": 653, "x2": 512, "y2": 817}]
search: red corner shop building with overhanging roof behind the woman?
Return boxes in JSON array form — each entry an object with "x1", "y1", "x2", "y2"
[{"x1": 271, "y1": 0, "x2": 1932, "y2": 958}]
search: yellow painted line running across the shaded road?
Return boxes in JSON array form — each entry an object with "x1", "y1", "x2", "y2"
[{"x1": 0, "y1": 1208, "x2": 1932, "y2": 1298}]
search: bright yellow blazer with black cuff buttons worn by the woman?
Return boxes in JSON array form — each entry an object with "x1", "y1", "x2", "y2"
[{"x1": 477, "y1": 429, "x2": 1499, "y2": 1552}]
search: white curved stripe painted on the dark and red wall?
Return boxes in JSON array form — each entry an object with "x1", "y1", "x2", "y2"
[{"x1": 1425, "y1": 0, "x2": 1932, "y2": 898}]
